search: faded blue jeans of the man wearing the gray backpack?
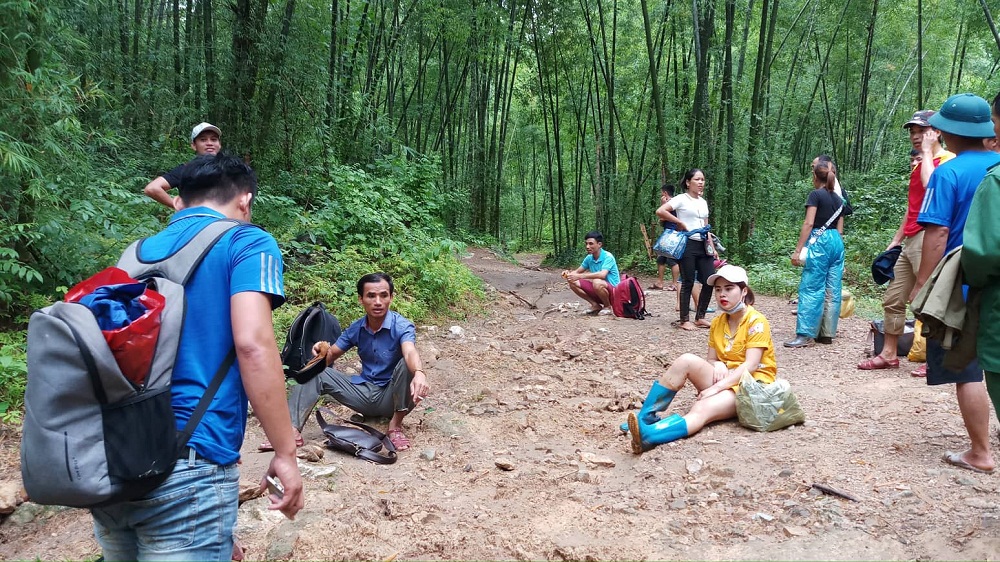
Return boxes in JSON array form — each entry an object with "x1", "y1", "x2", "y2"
[{"x1": 91, "y1": 459, "x2": 240, "y2": 562}]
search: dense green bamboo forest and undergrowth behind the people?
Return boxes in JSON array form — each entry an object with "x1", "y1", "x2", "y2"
[{"x1": 0, "y1": 0, "x2": 1000, "y2": 412}]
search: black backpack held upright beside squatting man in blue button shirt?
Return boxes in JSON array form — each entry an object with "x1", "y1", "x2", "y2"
[{"x1": 281, "y1": 302, "x2": 341, "y2": 384}]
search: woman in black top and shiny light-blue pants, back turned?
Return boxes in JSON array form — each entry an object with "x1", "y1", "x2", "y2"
[{"x1": 785, "y1": 156, "x2": 844, "y2": 347}]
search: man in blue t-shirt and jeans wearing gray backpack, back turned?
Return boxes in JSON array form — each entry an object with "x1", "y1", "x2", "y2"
[{"x1": 91, "y1": 154, "x2": 303, "y2": 560}]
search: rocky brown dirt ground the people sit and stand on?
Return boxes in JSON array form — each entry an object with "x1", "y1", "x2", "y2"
[{"x1": 0, "y1": 249, "x2": 1000, "y2": 560}]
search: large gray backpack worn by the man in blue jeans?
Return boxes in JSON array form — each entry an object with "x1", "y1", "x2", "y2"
[{"x1": 21, "y1": 219, "x2": 246, "y2": 508}]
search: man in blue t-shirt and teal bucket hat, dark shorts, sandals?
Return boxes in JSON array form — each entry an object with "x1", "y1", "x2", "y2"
[{"x1": 909, "y1": 94, "x2": 1000, "y2": 472}]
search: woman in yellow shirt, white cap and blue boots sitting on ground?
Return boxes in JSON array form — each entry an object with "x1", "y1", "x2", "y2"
[{"x1": 621, "y1": 265, "x2": 778, "y2": 455}]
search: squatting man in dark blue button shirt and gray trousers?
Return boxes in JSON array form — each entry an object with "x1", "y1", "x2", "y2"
[{"x1": 260, "y1": 273, "x2": 430, "y2": 451}]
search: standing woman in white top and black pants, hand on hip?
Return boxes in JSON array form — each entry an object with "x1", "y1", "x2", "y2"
[{"x1": 656, "y1": 168, "x2": 715, "y2": 330}]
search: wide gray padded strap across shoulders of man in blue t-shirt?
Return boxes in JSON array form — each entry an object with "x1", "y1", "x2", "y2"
[{"x1": 118, "y1": 219, "x2": 259, "y2": 285}]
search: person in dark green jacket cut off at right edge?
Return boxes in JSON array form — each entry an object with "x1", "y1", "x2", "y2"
[{"x1": 962, "y1": 93, "x2": 1000, "y2": 434}]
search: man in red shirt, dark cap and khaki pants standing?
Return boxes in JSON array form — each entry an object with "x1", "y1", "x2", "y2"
[{"x1": 858, "y1": 109, "x2": 955, "y2": 377}]
